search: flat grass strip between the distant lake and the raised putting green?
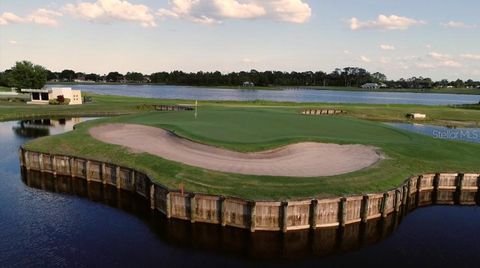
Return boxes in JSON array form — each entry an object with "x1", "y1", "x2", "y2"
[{"x1": 0, "y1": 93, "x2": 480, "y2": 127}]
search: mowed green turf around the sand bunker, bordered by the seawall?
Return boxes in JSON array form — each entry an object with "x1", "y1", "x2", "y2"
[{"x1": 26, "y1": 106, "x2": 480, "y2": 200}]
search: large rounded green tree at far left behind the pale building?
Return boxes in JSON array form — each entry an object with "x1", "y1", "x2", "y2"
[{"x1": 7, "y1": 61, "x2": 47, "y2": 89}]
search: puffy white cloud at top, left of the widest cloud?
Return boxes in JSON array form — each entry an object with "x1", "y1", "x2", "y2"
[{"x1": 64, "y1": 0, "x2": 157, "y2": 27}]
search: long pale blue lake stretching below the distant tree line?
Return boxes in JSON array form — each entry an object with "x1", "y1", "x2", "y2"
[{"x1": 50, "y1": 85, "x2": 480, "y2": 105}]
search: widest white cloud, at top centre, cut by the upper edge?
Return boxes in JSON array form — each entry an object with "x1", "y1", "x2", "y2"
[{"x1": 156, "y1": 0, "x2": 312, "y2": 24}]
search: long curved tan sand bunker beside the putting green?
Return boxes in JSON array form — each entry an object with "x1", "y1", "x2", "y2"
[{"x1": 90, "y1": 124, "x2": 381, "y2": 177}]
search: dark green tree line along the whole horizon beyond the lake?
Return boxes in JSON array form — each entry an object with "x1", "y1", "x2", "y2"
[{"x1": 0, "y1": 61, "x2": 480, "y2": 89}]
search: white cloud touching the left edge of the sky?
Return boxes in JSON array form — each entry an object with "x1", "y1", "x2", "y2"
[{"x1": 0, "y1": 8, "x2": 62, "y2": 26}]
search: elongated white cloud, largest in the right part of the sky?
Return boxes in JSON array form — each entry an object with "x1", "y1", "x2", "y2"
[{"x1": 349, "y1": 15, "x2": 426, "y2": 31}]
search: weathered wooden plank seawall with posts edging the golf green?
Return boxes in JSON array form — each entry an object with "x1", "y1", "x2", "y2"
[{"x1": 20, "y1": 148, "x2": 480, "y2": 232}]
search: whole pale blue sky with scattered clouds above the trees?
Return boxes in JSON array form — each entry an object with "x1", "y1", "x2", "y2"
[{"x1": 0, "y1": 0, "x2": 480, "y2": 80}]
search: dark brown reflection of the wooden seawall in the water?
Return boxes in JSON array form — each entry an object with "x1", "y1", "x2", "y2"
[{"x1": 22, "y1": 170, "x2": 480, "y2": 260}]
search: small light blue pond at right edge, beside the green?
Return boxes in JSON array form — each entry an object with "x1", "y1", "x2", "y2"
[{"x1": 387, "y1": 123, "x2": 480, "y2": 143}]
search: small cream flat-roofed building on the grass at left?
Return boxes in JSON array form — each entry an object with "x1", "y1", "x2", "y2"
[{"x1": 21, "y1": 87, "x2": 82, "y2": 105}]
